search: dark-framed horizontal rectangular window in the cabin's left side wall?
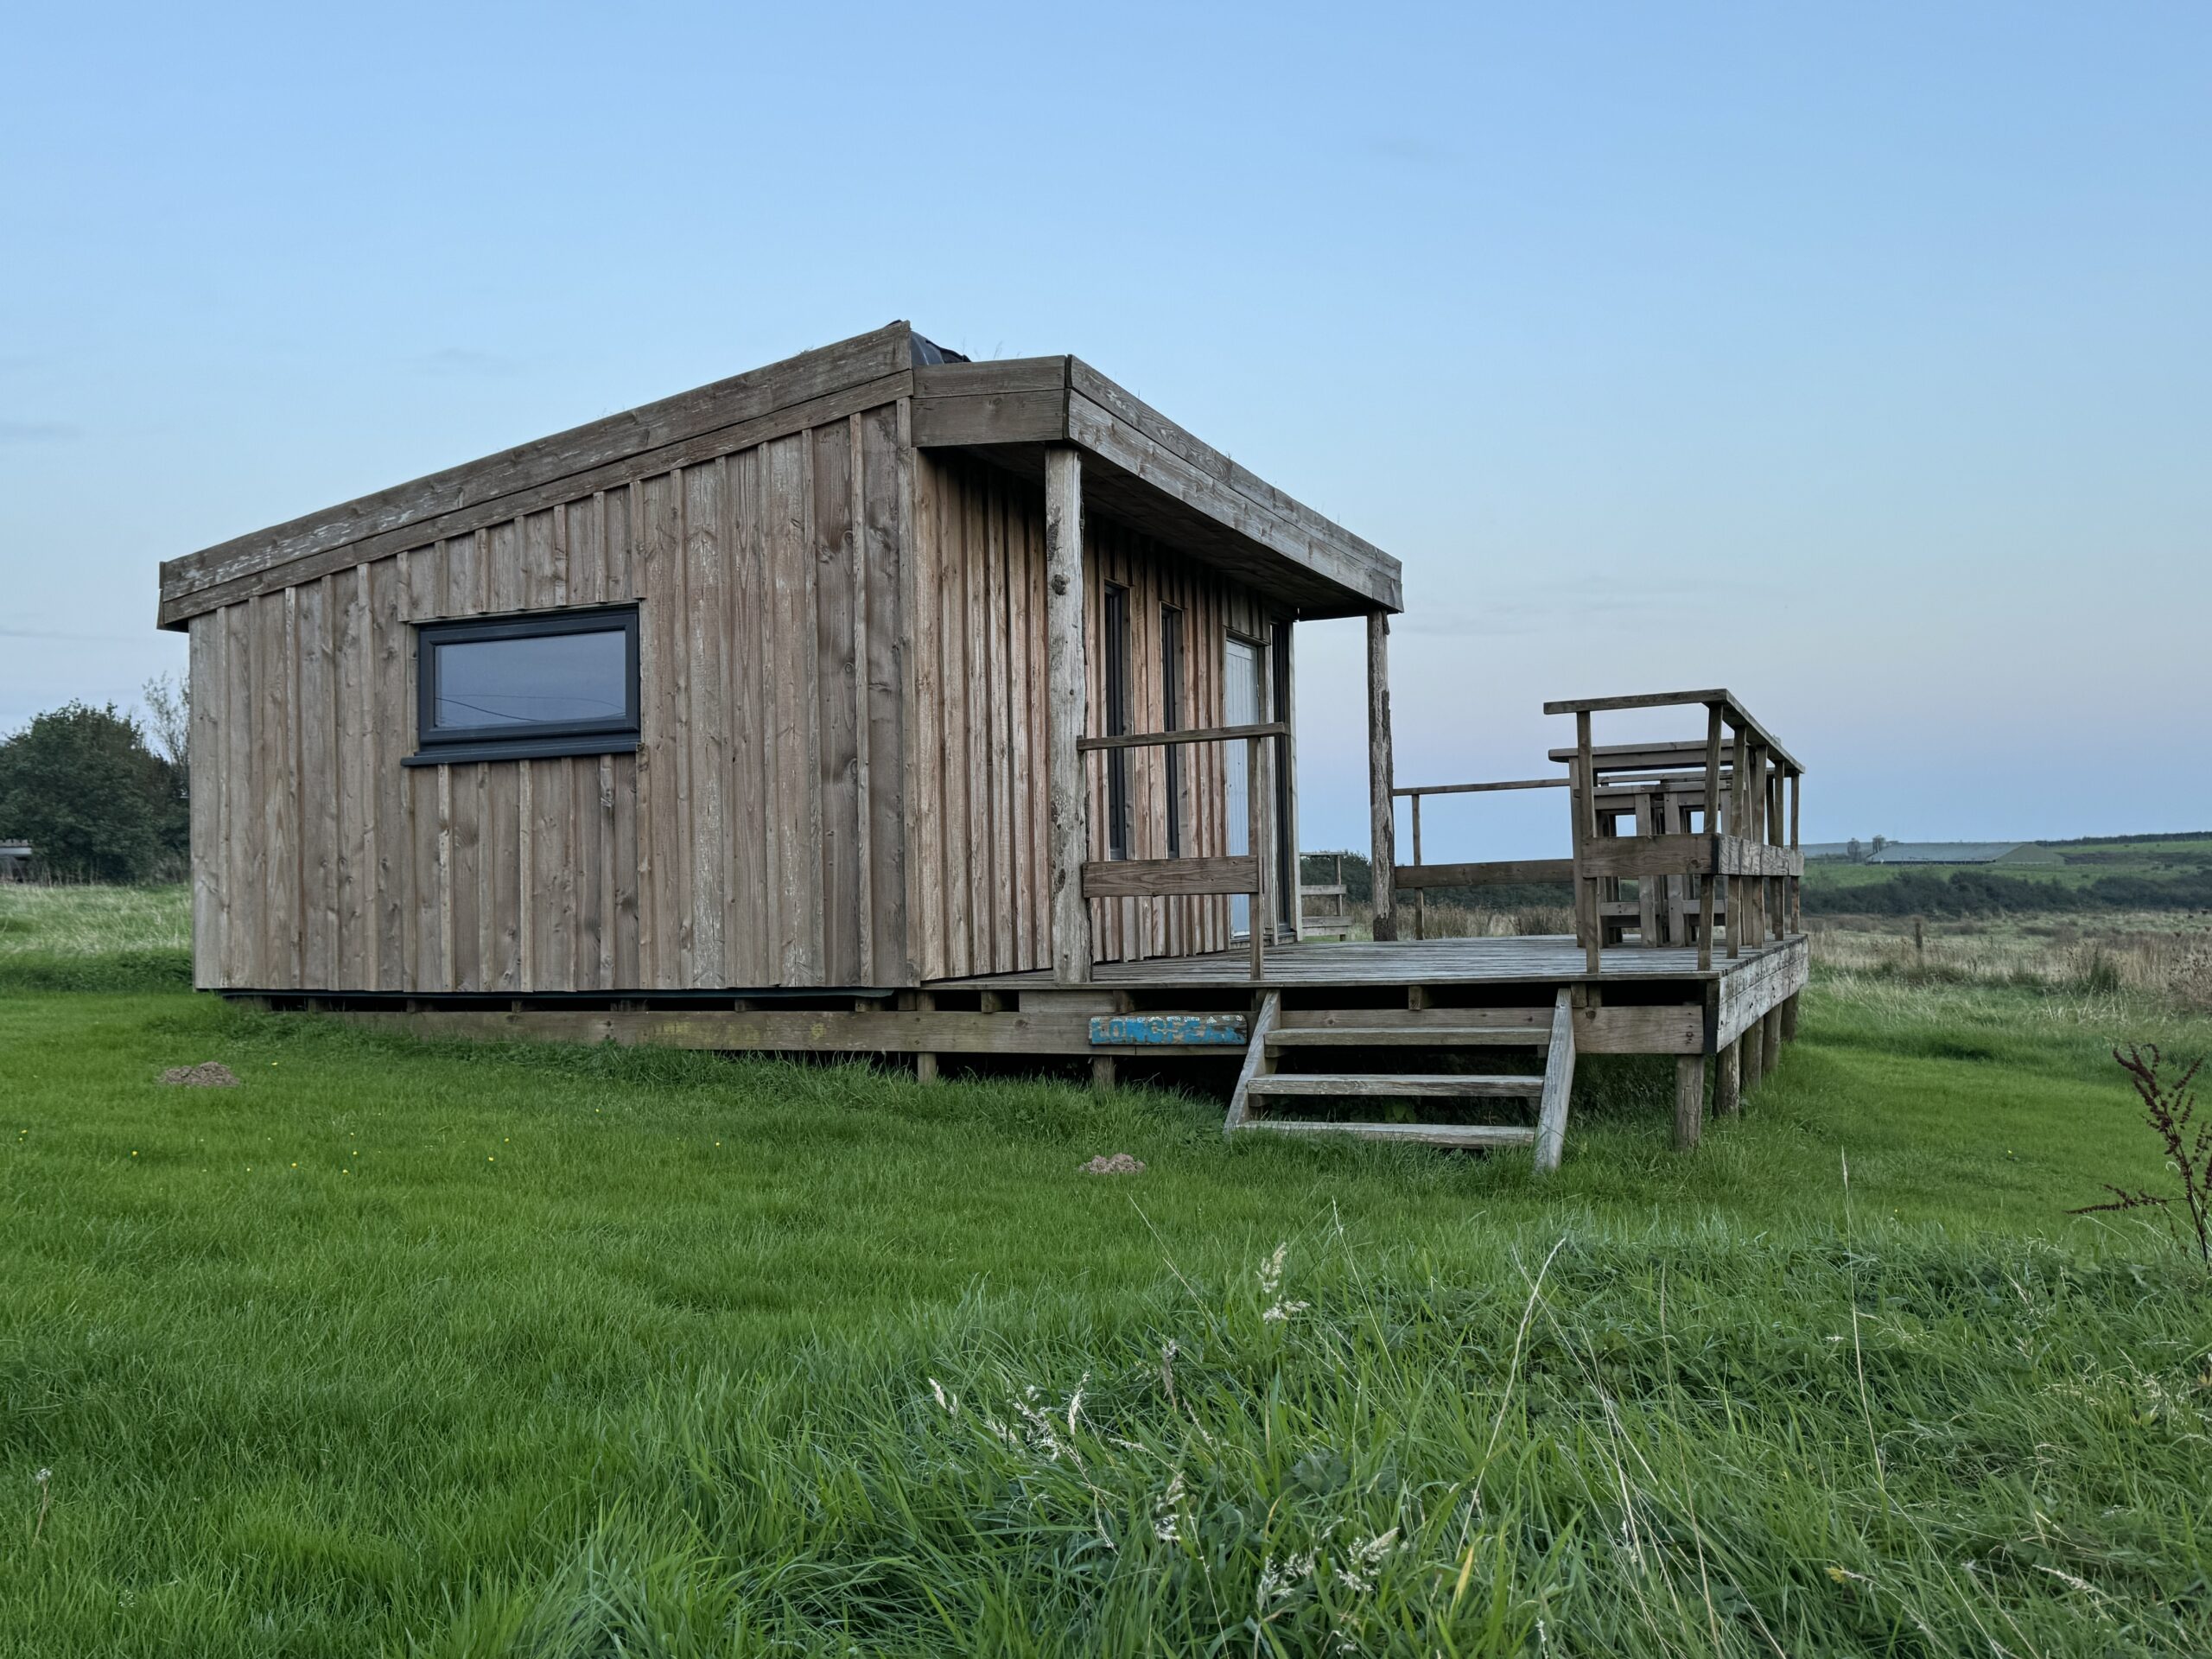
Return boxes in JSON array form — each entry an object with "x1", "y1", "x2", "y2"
[{"x1": 407, "y1": 606, "x2": 637, "y2": 766}]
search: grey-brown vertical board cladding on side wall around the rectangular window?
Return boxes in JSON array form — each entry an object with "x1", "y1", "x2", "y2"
[{"x1": 188, "y1": 404, "x2": 913, "y2": 993}]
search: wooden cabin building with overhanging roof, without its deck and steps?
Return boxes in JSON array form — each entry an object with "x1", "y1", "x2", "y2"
[{"x1": 159, "y1": 323, "x2": 1398, "y2": 998}]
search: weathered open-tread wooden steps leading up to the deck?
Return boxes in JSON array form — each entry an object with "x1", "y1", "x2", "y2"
[{"x1": 1225, "y1": 988, "x2": 1575, "y2": 1173}]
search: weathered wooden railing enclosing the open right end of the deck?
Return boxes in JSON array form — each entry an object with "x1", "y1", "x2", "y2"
[{"x1": 1391, "y1": 690, "x2": 1805, "y2": 973}]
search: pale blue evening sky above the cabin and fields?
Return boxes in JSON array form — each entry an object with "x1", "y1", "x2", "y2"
[{"x1": 0, "y1": 4, "x2": 2212, "y2": 856}]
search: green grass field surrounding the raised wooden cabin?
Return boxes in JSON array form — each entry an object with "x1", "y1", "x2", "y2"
[{"x1": 0, "y1": 889, "x2": 2212, "y2": 1656}]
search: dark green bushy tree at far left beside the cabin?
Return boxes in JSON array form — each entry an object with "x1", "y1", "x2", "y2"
[{"x1": 0, "y1": 703, "x2": 175, "y2": 880}]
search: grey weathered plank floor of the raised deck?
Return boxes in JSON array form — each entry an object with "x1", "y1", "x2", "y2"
[{"x1": 931, "y1": 933, "x2": 1802, "y2": 991}]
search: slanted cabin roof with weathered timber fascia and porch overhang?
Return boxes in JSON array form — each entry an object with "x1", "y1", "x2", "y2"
[{"x1": 159, "y1": 323, "x2": 1402, "y2": 628}]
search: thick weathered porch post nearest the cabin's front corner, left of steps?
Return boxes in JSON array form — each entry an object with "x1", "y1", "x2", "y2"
[{"x1": 1044, "y1": 447, "x2": 1090, "y2": 984}]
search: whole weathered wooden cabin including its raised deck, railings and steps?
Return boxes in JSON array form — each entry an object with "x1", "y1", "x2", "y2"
[{"x1": 159, "y1": 323, "x2": 1805, "y2": 1168}]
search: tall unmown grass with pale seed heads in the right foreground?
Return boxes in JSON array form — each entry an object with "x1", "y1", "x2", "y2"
[{"x1": 397, "y1": 1217, "x2": 2212, "y2": 1659}]
